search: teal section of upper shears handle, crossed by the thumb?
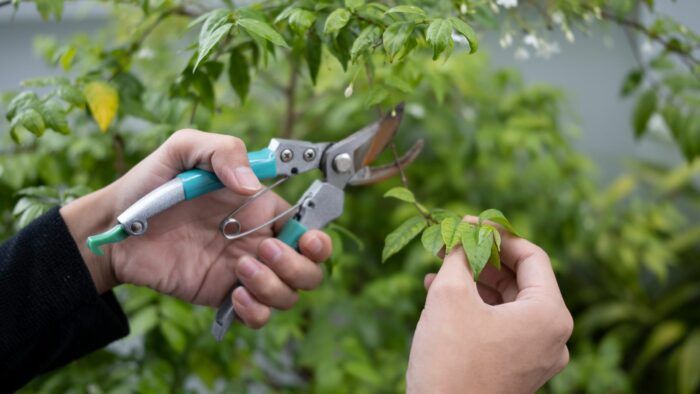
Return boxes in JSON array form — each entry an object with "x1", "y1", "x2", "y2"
[{"x1": 177, "y1": 148, "x2": 277, "y2": 200}]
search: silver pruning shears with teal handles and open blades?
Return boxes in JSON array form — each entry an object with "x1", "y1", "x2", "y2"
[{"x1": 87, "y1": 105, "x2": 423, "y2": 341}]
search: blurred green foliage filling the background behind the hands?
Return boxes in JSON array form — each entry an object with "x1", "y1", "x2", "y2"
[{"x1": 0, "y1": 0, "x2": 700, "y2": 393}]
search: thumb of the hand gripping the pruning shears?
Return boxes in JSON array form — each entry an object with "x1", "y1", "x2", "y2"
[{"x1": 162, "y1": 129, "x2": 262, "y2": 195}]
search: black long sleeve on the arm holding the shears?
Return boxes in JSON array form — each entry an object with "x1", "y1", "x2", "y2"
[{"x1": 0, "y1": 208, "x2": 129, "y2": 392}]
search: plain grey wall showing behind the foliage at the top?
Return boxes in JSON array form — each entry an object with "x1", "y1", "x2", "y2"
[{"x1": 0, "y1": 0, "x2": 700, "y2": 182}]
